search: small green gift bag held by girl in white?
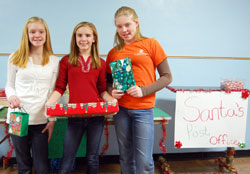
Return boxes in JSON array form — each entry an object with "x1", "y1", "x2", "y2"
[{"x1": 9, "y1": 109, "x2": 29, "y2": 137}]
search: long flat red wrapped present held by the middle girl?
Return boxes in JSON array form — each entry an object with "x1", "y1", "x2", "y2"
[{"x1": 46, "y1": 101, "x2": 119, "y2": 117}]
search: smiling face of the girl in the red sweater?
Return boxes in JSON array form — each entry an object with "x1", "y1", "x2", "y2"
[{"x1": 76, "y1": 26, "x2": 95, "y2": 53}]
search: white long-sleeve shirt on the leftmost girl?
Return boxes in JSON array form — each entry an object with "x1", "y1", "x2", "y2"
[{"x1": 5, "y1": 55, "x2": 59, "y2": 125}]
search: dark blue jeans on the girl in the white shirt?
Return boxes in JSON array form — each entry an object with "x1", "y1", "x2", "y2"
[{"x1": 10, "y1": 124, "x2": 49, "y2": 174}]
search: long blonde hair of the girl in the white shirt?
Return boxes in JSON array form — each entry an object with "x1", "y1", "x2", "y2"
[{"x1": 10, "y1": 17, "x2": 53, "y2": 68}]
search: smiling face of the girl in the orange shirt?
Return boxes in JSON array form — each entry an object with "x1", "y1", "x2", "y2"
[{"x1": 115, "y1": 15, "x2": 139, "y2": 44}]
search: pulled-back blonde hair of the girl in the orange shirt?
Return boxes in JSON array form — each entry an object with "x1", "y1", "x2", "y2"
[{"x1": 114, "y1": 6, "x2": 146, "y2": 50}]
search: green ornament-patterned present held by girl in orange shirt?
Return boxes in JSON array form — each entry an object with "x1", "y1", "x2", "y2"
[{"x1": 109, "y1": 57, "x2": 135, "y2": 91}]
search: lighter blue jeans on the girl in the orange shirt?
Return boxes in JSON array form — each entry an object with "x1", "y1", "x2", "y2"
[{"x1": 114, "y1": 106, "x2": 154, "y2": 174}]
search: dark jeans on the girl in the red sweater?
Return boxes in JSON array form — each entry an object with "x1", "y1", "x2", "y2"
[{"x1": 59, "y1": 117, "x2": 104, "y2": 174}]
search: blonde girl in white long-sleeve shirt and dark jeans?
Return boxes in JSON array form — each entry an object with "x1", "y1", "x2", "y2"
[{"x1": 5, "y1": 17, "x2": 59, "y2": 174}]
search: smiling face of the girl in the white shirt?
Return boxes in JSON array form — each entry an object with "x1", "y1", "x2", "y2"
[{"x1": 28, "y1": 22, "x2": 46, "y2": 48}]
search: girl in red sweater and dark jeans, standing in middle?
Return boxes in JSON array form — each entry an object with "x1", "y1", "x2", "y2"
[{"x1": 46, "y1": 22, "x2": 114, "y2": 174}]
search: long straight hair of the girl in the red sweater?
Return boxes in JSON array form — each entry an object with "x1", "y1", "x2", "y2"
[{"x1": 68, "y1": 22, "x2": 101, "y2": 69}]
